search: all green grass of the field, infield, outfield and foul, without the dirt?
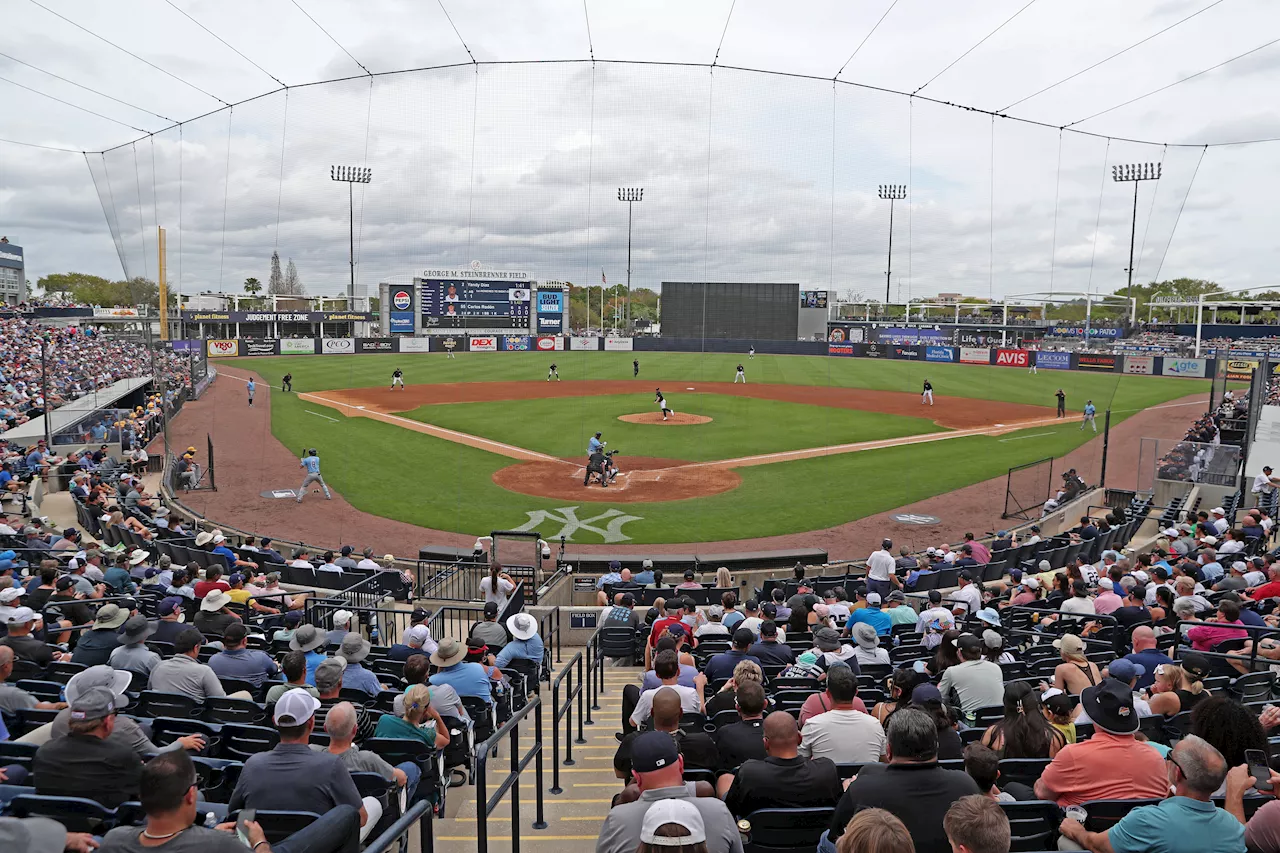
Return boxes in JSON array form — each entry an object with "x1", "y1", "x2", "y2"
[{"x1": 236, "y1": 352, "x2": 1208, "y2": 544}]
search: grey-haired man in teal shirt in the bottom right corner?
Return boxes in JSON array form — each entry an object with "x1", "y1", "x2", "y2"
[{"x1": 1060, "y1": 735, "x2": 1239, "y2": 853}]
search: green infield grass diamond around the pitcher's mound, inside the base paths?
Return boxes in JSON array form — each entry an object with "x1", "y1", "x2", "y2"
[{"x1": 404, "y1": 393, "x2": 942, "y2": 465}]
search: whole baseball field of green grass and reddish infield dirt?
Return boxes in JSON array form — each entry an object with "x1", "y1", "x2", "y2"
[{"x1": 199, "y1": 352, "x2": 1207, "y2": 544}]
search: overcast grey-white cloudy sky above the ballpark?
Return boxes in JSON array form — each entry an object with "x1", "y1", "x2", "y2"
[{"x1": 0, "y1": 0, "x2": 1280, "y2": 300}]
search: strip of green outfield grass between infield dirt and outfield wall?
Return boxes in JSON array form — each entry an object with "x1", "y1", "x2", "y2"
[{"x1": 227, "y1": 352, "x2": 1208, "y2": 412}]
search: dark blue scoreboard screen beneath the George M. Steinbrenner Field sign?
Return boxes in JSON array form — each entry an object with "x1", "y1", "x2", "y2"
[{"x1": 416, "y1": 270, "x2": 532, "y2": 329}]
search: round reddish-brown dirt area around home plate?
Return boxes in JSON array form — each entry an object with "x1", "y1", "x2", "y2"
[{"x1": 493, "y1": 455, "x2": 742, "y2": 503}]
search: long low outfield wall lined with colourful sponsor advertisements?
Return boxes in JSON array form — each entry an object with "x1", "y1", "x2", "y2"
[{"x1": 194, "y1": 334, "x2": 1213, "y2": 379}]
